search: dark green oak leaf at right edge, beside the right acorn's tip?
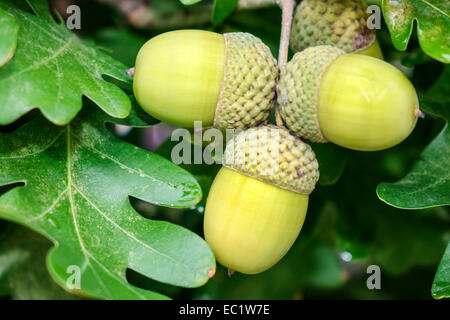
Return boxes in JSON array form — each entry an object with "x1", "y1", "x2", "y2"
[{"x1": 377, "y1": 66, "x2": 450, "y2": 209}]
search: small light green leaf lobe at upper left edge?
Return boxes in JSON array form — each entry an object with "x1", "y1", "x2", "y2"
[{"x1": 0, "y1": 8, "x2": 19, "y2": 67}]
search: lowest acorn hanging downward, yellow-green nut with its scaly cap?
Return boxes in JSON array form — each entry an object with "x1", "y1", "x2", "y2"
[{"x1": 204, "y1": 125, "x2": 319, "y2": 274}]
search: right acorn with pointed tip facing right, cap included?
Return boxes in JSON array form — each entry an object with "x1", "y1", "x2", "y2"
[{"x1": 277, "y1": 46, "x2": 423, "y2": 151}]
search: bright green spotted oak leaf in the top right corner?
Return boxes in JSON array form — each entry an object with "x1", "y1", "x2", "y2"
[{"x1": 382, "y1": 0, "x2": 450, "y2": 63}]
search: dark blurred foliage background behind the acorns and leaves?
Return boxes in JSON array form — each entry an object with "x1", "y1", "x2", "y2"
[{"x1": 0, "y1": 0, "x2": 450, "y2": 299}]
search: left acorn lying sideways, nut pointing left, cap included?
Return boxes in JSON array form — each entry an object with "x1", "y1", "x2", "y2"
[{"x1": 133, "y1": 30, "x2": 278, "y2": 130}]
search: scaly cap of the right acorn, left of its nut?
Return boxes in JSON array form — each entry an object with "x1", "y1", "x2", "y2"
[{"x1": 277, "y1": 46, "x2": 345, "y2": 142}]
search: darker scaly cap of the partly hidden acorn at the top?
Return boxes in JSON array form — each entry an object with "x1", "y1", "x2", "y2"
[{"x1": 290, "y1": 0, "x2": 376, "y2": 53}]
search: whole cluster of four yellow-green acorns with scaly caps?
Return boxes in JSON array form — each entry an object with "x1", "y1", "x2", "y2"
[{"x1": 134, "y1": 0, "x2": 421, "y2": 274}]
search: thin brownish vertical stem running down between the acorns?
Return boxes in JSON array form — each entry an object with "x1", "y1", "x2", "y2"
[{"x1": 275, "y1": 0, "x2": 296, "y2": 127}]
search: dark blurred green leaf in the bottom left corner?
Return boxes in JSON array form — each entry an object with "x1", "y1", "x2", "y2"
[{"x1": 0, "y1": 224, "x2": 76, "y2": 300}]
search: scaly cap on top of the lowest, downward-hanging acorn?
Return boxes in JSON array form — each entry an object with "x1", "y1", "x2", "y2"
[{"x1": 223, "y1": 125, "x2": 319, "y2": 197}]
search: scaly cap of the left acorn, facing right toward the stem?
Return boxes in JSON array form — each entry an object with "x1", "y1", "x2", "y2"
[{"x1": 214, "y1": 32, "x2": 278, "y2": 130}]
